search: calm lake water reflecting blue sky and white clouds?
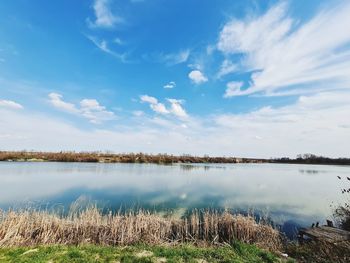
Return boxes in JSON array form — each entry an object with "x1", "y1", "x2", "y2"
[{"x1": 0, "y1": 162, "x2": 350, "y2": 237}]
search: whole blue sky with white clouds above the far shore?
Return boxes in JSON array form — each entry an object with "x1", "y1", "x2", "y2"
[{"x1": 0, "y1": 0, "x2": 350, "y2": 158}]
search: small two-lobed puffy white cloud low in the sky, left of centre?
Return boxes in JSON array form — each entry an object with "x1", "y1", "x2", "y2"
[{"x1": 49, "y1": 93, "x2": 115, "y2": 124}]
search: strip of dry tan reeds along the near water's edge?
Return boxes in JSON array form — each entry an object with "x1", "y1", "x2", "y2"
[{"x1": 0, "y1": 208, "x2": 281, "y2": 251}]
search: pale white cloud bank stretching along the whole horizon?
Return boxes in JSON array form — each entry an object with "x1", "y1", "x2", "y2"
[{"x1": 0, "y1": 91, "x2": 350, "y2": 158}]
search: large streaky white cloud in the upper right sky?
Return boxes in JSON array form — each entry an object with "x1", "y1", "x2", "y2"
[{"x1": 217, "y1": 1, "x2": 350, "y2": 95}]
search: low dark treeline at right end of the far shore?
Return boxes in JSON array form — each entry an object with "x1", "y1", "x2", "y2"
[{"x1": 272, "y1": 153, "x2": 350, "y2": 165}]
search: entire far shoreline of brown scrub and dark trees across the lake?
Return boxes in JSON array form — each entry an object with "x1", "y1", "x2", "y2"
[{"x1": 0, "y1": 151, "x2": 350, "y2": 165}]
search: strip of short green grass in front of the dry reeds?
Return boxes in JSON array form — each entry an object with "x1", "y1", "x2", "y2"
[{"x1": 0, "y1": 243, "x2": 293, "y2": 263}]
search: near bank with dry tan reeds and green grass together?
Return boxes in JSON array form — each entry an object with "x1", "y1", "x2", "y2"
[{"x1": 0, "y1": 207, "x2": 288, "y2": 263}]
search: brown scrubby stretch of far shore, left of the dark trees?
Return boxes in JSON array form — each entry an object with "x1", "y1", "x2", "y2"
[{"x1": 0, "y1": 151, "x2": 266, "y2": 164}]
